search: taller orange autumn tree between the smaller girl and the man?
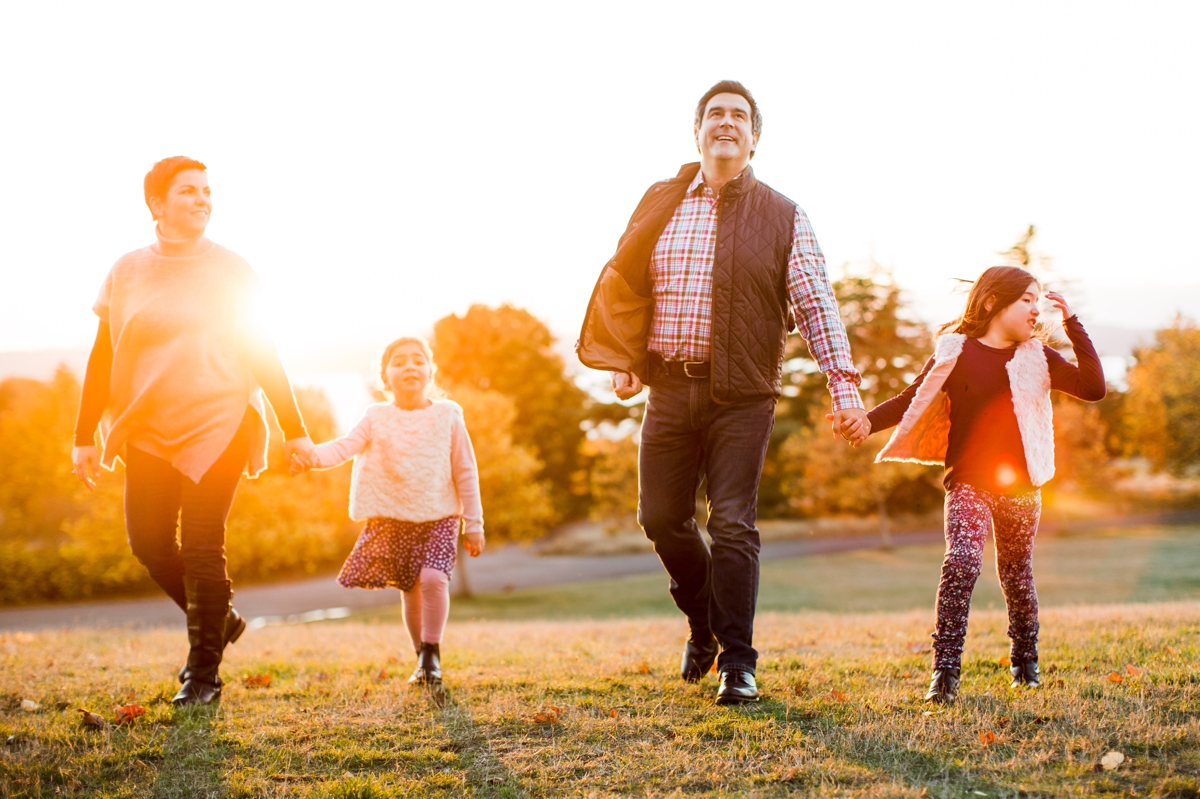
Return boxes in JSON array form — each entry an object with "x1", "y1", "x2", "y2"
[{"x1": 431, "y1": 305, "x2": 589, "y2": 518}]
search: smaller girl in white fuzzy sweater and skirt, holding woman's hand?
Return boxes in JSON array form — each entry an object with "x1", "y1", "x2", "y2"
[{"x1": 292, "y1": 338, "x2": 484, "y2": 685}]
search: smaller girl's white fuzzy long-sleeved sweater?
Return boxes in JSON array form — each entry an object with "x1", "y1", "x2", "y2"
[{"x1": 313, "y1": 400, "x2": 484, "y2": 533}]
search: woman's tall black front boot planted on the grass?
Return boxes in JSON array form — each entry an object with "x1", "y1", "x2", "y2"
[{"x1": 172, "y1": 577, "x2": 233, "y2": 707}]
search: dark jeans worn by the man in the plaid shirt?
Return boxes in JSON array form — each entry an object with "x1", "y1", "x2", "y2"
[{"x1": 637, "y1": 376, "x2": 775, "y2": 672}]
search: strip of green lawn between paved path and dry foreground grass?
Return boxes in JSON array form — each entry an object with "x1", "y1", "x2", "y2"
[{"x1": 436, "y1": 527, "x2": 1200, "y2": 621}]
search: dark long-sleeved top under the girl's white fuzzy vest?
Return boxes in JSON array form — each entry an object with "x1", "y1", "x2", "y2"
[{"x1": 868, "y1": 317, "x2": 1106, "y2": 494}]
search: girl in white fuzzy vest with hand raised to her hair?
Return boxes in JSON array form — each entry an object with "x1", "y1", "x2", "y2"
[{"x1": 845, "y1": 266, "x2": 1105, "y2": 702}]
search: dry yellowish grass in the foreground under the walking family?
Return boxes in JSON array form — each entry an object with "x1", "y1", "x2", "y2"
[{"x1": 0, "y1": 602, "x2": 1200, "y2": 798}]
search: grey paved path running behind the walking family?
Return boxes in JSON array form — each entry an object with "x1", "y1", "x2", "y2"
[{"x1": 0, "y1": 531, "x2": 942, "y2": 631}]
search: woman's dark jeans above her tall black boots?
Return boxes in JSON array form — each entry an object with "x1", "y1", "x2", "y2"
[{"x1": 125, "y1": 408, "x2": 258, "y2": 611}]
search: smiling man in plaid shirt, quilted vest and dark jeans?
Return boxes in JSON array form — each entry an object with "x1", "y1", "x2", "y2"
[{"x1": 577, "y1": 80, "x2": 865, "y2": 704}]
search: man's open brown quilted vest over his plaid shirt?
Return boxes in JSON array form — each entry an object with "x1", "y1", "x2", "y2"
[{"x1": 576, "y1": 163, "x2": 796, "y2": 403}]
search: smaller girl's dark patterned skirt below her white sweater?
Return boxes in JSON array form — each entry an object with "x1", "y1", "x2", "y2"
[{"x1": 337, "y1": 516, "x2": 458, "y2": 591}]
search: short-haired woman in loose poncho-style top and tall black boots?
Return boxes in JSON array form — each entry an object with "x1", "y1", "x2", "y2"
[{"x1": 72, "y1": 156, "x2": 312, "y2": 705}]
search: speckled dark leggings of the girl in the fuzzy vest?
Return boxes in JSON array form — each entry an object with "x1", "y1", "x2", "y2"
[{"x1": 934, "y1": 485, "x2": 1042, "y2": 668}]
